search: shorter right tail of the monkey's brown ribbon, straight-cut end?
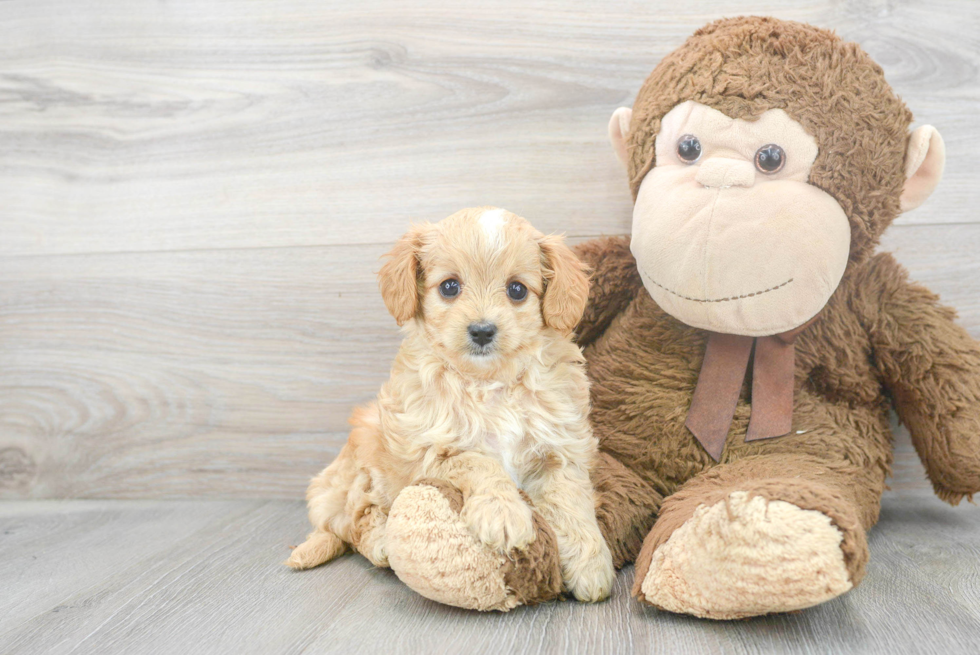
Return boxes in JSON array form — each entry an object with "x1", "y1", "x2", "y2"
[{"x1": 752, "y1": 335, "x2": 796, "y2": 441}]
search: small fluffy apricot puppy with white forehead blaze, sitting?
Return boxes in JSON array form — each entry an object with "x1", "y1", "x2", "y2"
[{"x1": 287, "y1": 208, "x2": 614, "y2": 601}]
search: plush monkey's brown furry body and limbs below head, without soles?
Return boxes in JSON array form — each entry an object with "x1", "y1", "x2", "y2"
[{"x1": 579, "y1": 238, "x2": 980, "y2": 583}]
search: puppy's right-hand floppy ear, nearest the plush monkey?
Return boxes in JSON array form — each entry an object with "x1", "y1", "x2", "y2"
[{"x1": 538, "y1": 235, "x2": 589, "y2": 334}]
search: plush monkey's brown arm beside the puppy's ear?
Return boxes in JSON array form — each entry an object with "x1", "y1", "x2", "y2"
[{"x1": 573, "y1": 237, "x2": 643, "y2": 348}]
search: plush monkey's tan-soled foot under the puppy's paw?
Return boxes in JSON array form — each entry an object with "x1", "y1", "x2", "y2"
[{"x1": 386, "y1": 480, "x2": 562, "y2": 612}]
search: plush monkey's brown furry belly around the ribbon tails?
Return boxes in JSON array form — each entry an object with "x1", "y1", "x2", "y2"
[{"x1": 586, "y1": 294, "x2": 891, "y2": 495}]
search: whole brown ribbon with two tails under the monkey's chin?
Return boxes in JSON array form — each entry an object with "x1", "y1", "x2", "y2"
[{"x1": 684, "y1": 318, "x2": 815, "y2": 462}]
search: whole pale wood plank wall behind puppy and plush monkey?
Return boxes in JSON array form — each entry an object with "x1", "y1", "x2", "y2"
[{"x1": 0, "y1": 0, "x2": 980, "y2": 498}]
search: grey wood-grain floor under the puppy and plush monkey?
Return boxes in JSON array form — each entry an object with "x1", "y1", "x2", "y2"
[{"x1": 0, "y1": 490, "x2": 980, "y2": 655}]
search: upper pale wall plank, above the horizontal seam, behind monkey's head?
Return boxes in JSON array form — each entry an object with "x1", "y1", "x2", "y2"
[{"x1": 0, "y1": 0, "x2": 980, "y2": 255}]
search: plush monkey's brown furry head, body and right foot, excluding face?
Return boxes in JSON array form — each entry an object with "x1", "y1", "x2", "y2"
[{"x1": 384, "y1": 18, "x2": 980, "y2": 618}]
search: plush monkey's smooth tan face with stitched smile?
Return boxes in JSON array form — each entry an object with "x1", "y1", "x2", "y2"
[{"x1": 632, "y1": 101, "x2": 851, "y2": 336}]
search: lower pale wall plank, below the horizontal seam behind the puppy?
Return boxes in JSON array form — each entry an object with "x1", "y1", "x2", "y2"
[{"x1": 0, "y1": 224, "x2": 980, "y2": 498}]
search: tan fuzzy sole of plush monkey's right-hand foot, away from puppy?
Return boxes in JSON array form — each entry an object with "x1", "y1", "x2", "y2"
[{"x1": 633, "y1": 491, "x2": 853, "y2": 619}]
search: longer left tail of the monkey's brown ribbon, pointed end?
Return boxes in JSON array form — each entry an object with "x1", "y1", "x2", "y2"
[{"x1": 684, "y1": 332, "x2": 756, "y2": 462}]
